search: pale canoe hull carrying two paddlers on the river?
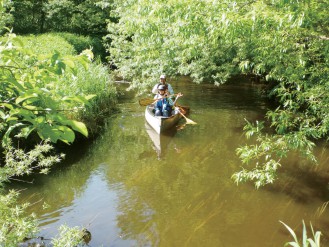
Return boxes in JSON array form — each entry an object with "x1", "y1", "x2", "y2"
[{"x1": 145, "y1": 105, "x2": 188, "y2": 134}]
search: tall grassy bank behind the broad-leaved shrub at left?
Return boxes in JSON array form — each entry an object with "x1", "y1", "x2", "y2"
[{"x1": 19, "y1": 33, "x2": 117, "y2": 135}]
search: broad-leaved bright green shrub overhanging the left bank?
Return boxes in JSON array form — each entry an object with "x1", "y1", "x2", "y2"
[{"x1": 0, "y1": 31, "x2": 93, "y2": 143}]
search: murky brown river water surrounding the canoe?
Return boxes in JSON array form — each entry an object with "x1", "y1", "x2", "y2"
[{"x1": 10, "y1": 76, "x2": 329, "y2": 247}]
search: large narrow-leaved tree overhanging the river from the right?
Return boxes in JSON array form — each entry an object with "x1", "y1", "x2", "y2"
[{"x1": 109, "y1": 0, "x2": 329, "y2": 187}]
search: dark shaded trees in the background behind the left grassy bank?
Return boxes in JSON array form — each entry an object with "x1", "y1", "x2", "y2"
[{"x1": 13, "y1": 0, "x2": 110, "y2": 36}]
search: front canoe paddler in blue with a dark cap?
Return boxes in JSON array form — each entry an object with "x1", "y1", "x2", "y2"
[{"x1": 154, "y1": 84, "x2": 183, "y2": 117}]
